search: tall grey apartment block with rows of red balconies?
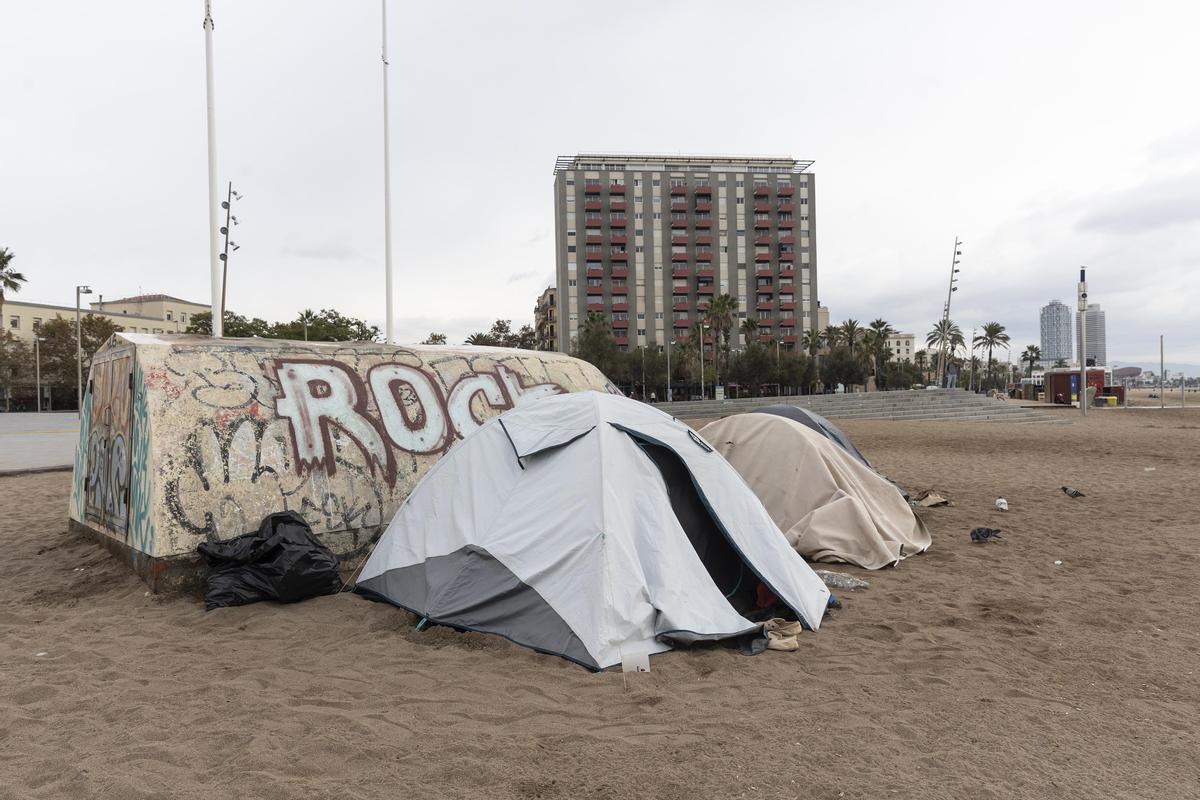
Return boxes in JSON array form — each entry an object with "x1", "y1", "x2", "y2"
[{"x1": 554, "y1": 154, "x2": 817, "y2": 351}]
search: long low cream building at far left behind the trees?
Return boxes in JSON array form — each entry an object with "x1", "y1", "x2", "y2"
[{"x1": 4, "y1": 294, "x2": 210, "y2": 342}]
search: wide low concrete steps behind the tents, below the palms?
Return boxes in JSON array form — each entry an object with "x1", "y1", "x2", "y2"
[{"x1": 655, "y1": 389, "x2": 1069, "y2": 425}]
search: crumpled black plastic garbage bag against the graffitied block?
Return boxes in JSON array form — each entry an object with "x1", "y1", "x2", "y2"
[{"x1": 197, "y1": 511, "x2": 342, "y2": 610}]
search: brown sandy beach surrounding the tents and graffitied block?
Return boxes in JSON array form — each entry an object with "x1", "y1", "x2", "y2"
[{"x1": 0, "y1": 410, "x2": 1200, "y2": 800}]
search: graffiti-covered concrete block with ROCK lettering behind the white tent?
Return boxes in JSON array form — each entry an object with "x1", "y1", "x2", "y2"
[{"x1": 71, "y1": 333, "x2": 614, "y2": 589}]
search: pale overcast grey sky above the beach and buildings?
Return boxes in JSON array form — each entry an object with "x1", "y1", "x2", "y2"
[{"x1": 0, "y1": 0, "x2": 1200, "y2": 362}]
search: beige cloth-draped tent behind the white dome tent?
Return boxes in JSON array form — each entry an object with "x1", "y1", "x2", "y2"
[{"x1": 700, "y1": 414, "x2": 930, "y2": 570}]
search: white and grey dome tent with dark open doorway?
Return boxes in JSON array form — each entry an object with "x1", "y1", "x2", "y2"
[{"x1": 358, "y1": 392, "x2": 829, "y2": 669}]
